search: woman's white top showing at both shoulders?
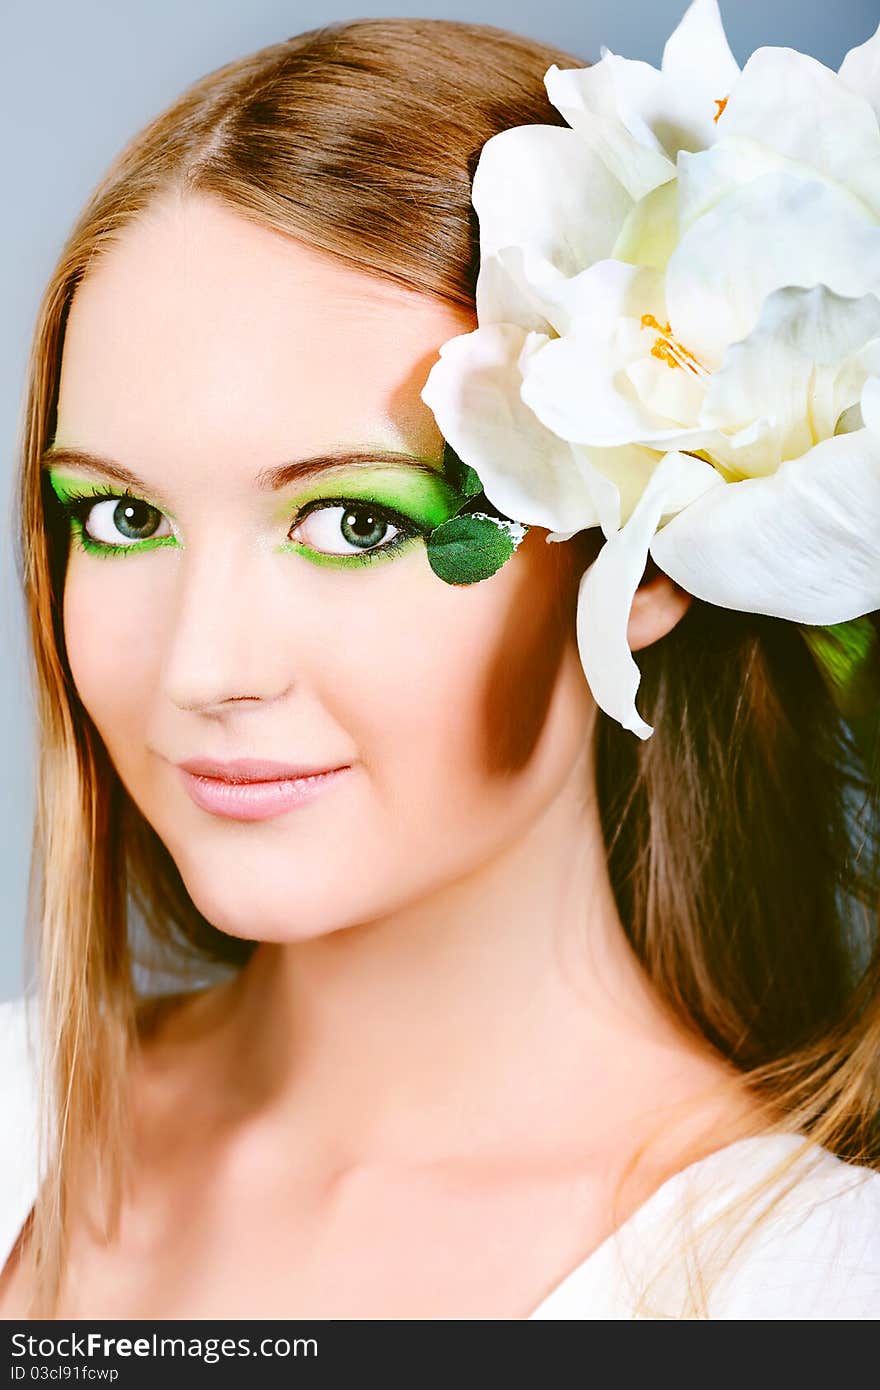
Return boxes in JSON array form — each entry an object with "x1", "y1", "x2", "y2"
[{"x1": 0, "y1": 997, "x2": 880, "y2": 1321}]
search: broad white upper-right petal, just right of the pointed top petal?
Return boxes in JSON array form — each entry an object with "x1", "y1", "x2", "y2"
[{"x1": 719, "y1": 49, "x2": 880, "y2": 217}]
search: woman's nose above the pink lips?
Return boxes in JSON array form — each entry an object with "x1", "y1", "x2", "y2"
[{"x1": 163, "y1": 541, "x2": 293, "y2": 713}]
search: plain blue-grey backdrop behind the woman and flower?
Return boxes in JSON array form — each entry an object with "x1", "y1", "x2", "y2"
[{"x1": 0, "y1": 0, "x2": 879, "y2": 999}]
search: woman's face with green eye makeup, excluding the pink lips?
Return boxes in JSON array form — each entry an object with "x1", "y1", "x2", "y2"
[{"x1": 51, "y1": 197, "x2": 595, "y2": 941}]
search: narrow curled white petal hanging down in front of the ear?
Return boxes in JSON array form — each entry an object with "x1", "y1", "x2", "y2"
[{"x1": 577, "y1": 453, "x2": 726, "y2": 738}]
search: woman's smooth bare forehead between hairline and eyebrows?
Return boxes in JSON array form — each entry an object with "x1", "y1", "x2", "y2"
[{"x1": 56, "y1": 196, "x2": 475, "y2": 470}]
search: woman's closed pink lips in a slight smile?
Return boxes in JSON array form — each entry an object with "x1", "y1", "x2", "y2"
[{"x1": 178, "y1": 758, "x2": 350, "y2": 820}]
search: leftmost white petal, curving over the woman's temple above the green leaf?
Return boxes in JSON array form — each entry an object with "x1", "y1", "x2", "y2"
[{"x1": 421, "y1": 324, "x2": 606, "y2": 531}]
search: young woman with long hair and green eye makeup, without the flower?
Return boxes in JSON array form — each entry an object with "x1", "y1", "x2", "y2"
[{"x1": 0, "y1": 8, "x2": 880, "y2": 1319}]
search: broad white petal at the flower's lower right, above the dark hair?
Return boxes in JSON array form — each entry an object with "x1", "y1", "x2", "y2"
[{"x1": 651, "y1": 430, "x2": 880, "y2": 626}]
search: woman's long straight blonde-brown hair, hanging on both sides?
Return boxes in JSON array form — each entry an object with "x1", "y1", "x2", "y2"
[{"x1": 18, "y1": 19, "x2": 880, "y2": 1316}]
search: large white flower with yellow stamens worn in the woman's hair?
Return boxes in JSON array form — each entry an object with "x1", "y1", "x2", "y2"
[{"x1": 423, "y1": 0, "x2": 880, "y2": 738}]
